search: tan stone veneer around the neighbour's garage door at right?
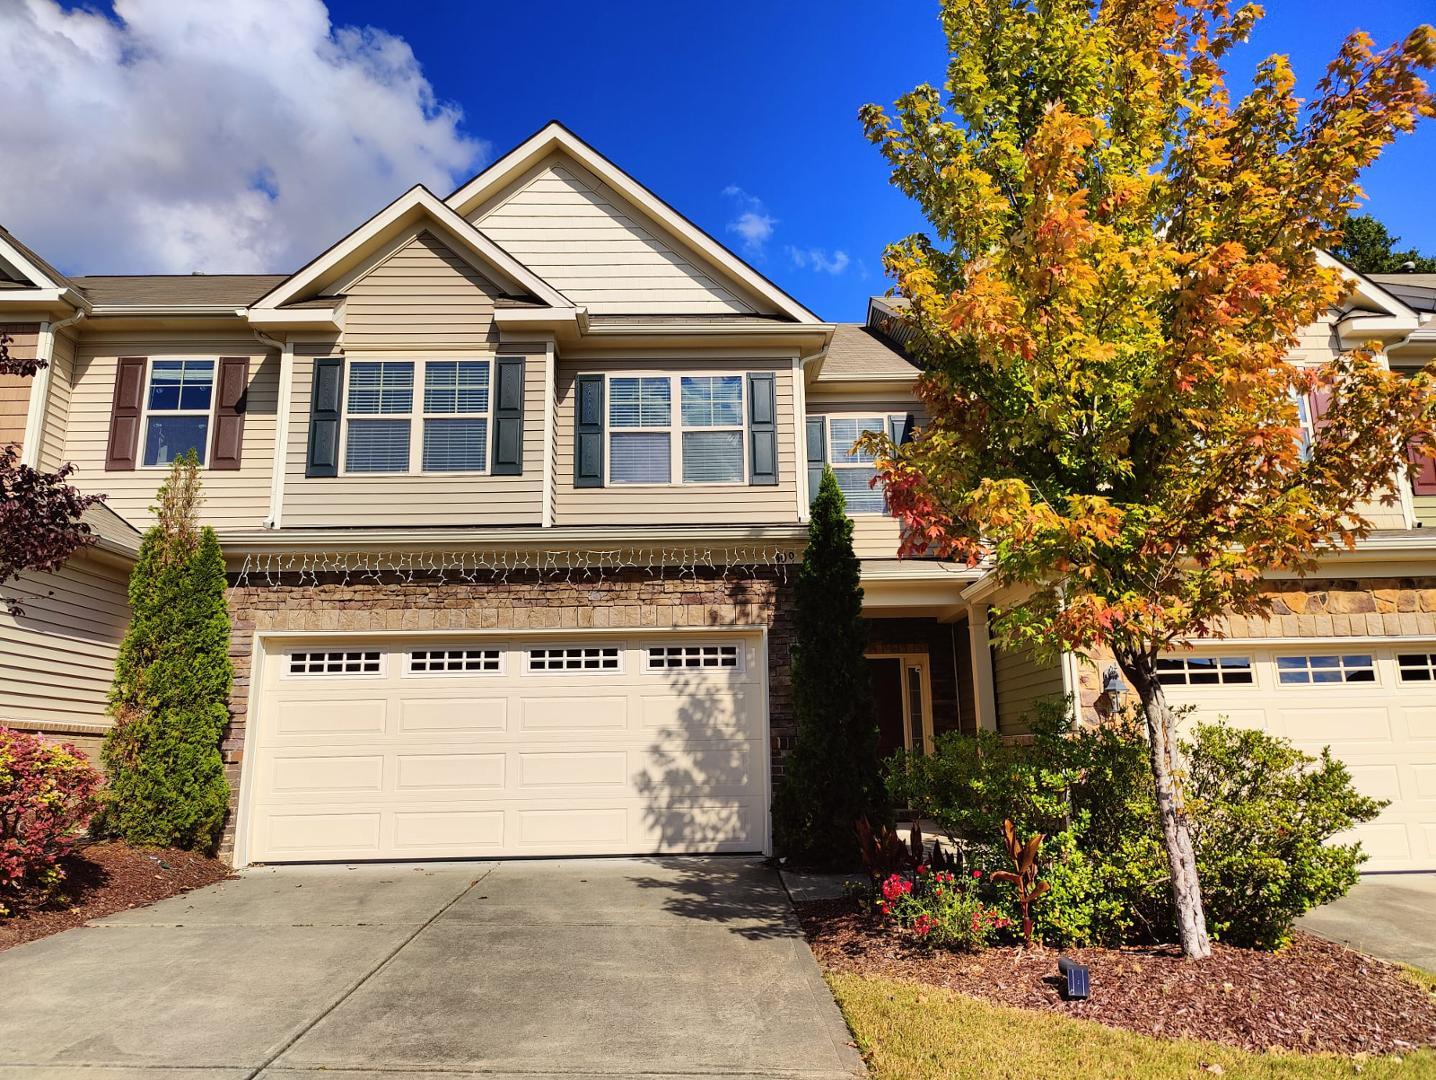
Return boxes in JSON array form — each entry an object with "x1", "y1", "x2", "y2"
[{"x1": 1077, "y1": 577, "x2": 1436, "y2": 720}]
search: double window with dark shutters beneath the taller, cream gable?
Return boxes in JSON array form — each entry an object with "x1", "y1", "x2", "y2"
[{"x1": 607, "y1": 375, "x2": 744, "y2": 484}]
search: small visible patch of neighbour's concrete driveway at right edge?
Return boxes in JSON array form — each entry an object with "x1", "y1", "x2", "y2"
[{"x1": 1297, "y1": 873, "x2": 1436, "y2": 971}]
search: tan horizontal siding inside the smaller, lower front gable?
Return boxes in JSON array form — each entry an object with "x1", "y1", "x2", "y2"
[{"x1": 342, "y1": 233, "x2": 501, "y2": 353}]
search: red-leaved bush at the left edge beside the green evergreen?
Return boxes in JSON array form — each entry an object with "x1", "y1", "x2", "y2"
[{"x1": 0, "y1": 728, "x2": 101, "y2": 915}]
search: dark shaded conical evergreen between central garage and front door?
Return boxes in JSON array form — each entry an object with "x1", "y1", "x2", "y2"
[{"x1": 773, "y1": 468, "x2": 887, "y2": 866}]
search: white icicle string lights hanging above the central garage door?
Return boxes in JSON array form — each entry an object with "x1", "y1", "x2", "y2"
[{"x1": 236, "y1": 544, "x2": 801, "y2": 589}]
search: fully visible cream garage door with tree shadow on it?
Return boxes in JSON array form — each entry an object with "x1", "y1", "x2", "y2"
[{"x1": 241, "y1": 632, "x2": 768, "y2": 862}]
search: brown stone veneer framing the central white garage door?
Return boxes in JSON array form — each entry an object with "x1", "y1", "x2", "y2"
[{"x1": 220, "y1": 567, "x2": 797, "y2": 857}]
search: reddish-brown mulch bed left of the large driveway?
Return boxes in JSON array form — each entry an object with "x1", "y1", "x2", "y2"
[{"x1": 0, "y1": 840, "x2": 233, "y2": 952}]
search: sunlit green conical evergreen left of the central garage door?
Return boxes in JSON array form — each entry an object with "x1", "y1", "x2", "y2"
[{"x1": 96, "y1": 452, "x2": 234, "y2": 852}]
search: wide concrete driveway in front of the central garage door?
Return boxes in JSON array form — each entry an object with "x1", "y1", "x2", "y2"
[{"x1": 0, "y1": 857, "x2": 863, "y2": 1080}]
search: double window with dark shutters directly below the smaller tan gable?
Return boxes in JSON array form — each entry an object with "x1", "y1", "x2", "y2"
[{"x1": 343, "y1": 360, "x2": 491, "y2": 474}]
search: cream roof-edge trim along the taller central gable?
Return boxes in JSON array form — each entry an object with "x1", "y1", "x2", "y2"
[{"x1": 444, "y1": 121, "x2": 821, "y2": 323}]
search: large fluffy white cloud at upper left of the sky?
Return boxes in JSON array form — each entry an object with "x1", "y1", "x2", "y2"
[{"x1": 0, "y1": 0, "x2": 488, "y2": 273}]
